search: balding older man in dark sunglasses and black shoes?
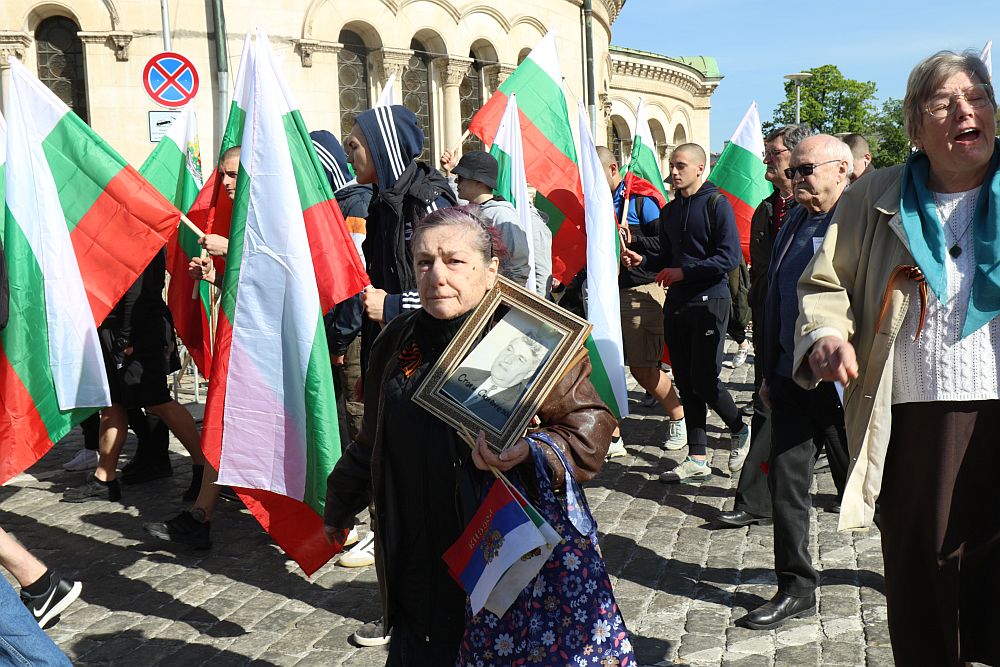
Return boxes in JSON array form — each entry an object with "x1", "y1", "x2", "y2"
[{"x1": 737, "y1": 134, "x2": 854, "y2": 630}]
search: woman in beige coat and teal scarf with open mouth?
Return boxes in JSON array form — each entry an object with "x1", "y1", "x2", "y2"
[{"x1": 795, "y1": 51, "x2": 1000, "y2": 666}]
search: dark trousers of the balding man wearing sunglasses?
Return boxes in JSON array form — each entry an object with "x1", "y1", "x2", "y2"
[{"x1": 767, "y1": 376, "x2": 850, "y2": 597}]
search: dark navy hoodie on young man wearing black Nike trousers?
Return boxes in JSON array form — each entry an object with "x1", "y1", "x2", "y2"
[{"x1": 644, "y1": 181, "x2": 741, "y2": 307}]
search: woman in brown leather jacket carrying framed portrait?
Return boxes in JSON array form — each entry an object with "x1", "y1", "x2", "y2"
[{"x1": 325, "y1": 207, "x2": 630, "y2": 667}]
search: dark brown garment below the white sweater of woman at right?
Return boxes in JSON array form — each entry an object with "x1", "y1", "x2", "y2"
[{"x1": 879, "y1": 401, "x2": 1000, "y2": 667}]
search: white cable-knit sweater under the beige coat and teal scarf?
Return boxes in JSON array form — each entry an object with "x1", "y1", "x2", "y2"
[{"x1": 892, "y1": 188, "x2": 1000, "y2": 404}]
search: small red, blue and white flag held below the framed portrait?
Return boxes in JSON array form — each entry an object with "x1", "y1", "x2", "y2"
[{"x1": 444, "y1": 480, "x2": 546, "y2": 615}]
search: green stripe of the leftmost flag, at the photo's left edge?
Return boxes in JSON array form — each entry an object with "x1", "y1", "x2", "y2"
[{"x1": 0, "y1": 208, "x2": 94, "y2": 442}]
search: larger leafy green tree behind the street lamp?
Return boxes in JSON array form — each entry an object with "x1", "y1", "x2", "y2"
[{"x1": 764, "y1": 65, "x2": 877, "y2": 136}]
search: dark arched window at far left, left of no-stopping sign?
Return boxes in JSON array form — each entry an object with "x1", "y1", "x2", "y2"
[{"x1": 35, "y1": 16, "x2": 90, "y2": 123}]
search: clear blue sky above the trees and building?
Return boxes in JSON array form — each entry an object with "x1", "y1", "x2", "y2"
[{"x1": 611, "y1": 0, "x2": 1000, "y2": 151}]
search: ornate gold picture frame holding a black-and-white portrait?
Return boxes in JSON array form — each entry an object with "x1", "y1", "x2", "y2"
[{"x1": 413, "y1": 277, "x2": 593, "y2": 453}]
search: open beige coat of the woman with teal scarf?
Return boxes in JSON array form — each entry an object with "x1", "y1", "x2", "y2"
[{"x1": 793, "y1": 165, "x2": 920, "y2": 530}]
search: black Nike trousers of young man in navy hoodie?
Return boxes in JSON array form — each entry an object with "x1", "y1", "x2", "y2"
[{"x1": 663, "y1": 295, "x2": 743, "y2": 454}]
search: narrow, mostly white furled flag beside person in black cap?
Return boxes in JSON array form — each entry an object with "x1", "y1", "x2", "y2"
[{"x1": 490, "y1": 94, "x2": 536, "y2": 292}]
